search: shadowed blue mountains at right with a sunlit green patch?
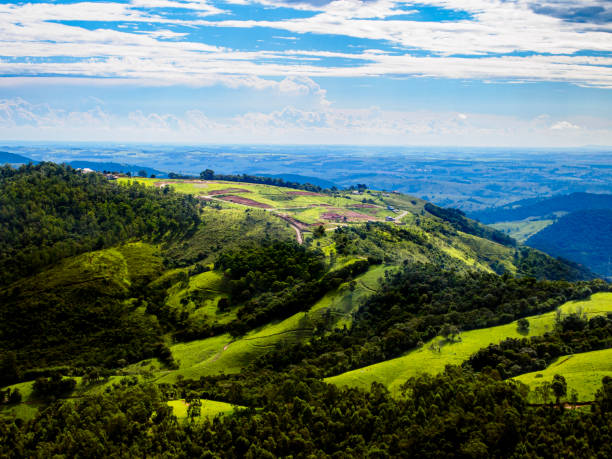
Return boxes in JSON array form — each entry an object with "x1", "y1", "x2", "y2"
[{"x1": 470, "y1": 193, "x2": 612, "y2": 278}]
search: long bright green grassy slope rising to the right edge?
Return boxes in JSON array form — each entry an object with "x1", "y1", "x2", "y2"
[{"x1": 326, "y1": 293, "x2": 612, "y2": 391}]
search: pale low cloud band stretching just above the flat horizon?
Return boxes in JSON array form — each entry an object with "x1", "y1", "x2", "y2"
[{"x1": 0, "y1": 98, "x2": 612, "y2": 146}]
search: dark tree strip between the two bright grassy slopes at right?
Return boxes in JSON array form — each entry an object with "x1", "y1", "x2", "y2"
[{"x1": 464, "y1": 313, "x2": 612, "y2": 378}]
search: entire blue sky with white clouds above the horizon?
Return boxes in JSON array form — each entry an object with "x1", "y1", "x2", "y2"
[{"x1": 0, "y1": 0, "x2": 612, "y2": 147}]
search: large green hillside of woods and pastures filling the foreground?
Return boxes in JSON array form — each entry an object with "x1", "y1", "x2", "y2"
[{"x1": 0, "y1": 163, "x2": 612, "y2": 457}]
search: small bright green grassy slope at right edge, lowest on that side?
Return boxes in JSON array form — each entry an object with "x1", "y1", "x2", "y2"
[{"x1": 514, "y1": 349, "x2": 612, "y2": 402}]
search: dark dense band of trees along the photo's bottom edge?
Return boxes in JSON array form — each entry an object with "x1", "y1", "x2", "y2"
[{"x1": 0, "y1": 367, "x2": 612, "y2": 458}]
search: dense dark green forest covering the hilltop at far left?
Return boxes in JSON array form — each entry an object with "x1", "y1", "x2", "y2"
[{"x1": 0, "y1": 163, "x2": 200, "y2": 285}]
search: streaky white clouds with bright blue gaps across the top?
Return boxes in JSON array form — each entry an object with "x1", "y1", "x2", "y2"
[{"x1": 0, "y1": 0, "x2": 612, "y2": 88}]
